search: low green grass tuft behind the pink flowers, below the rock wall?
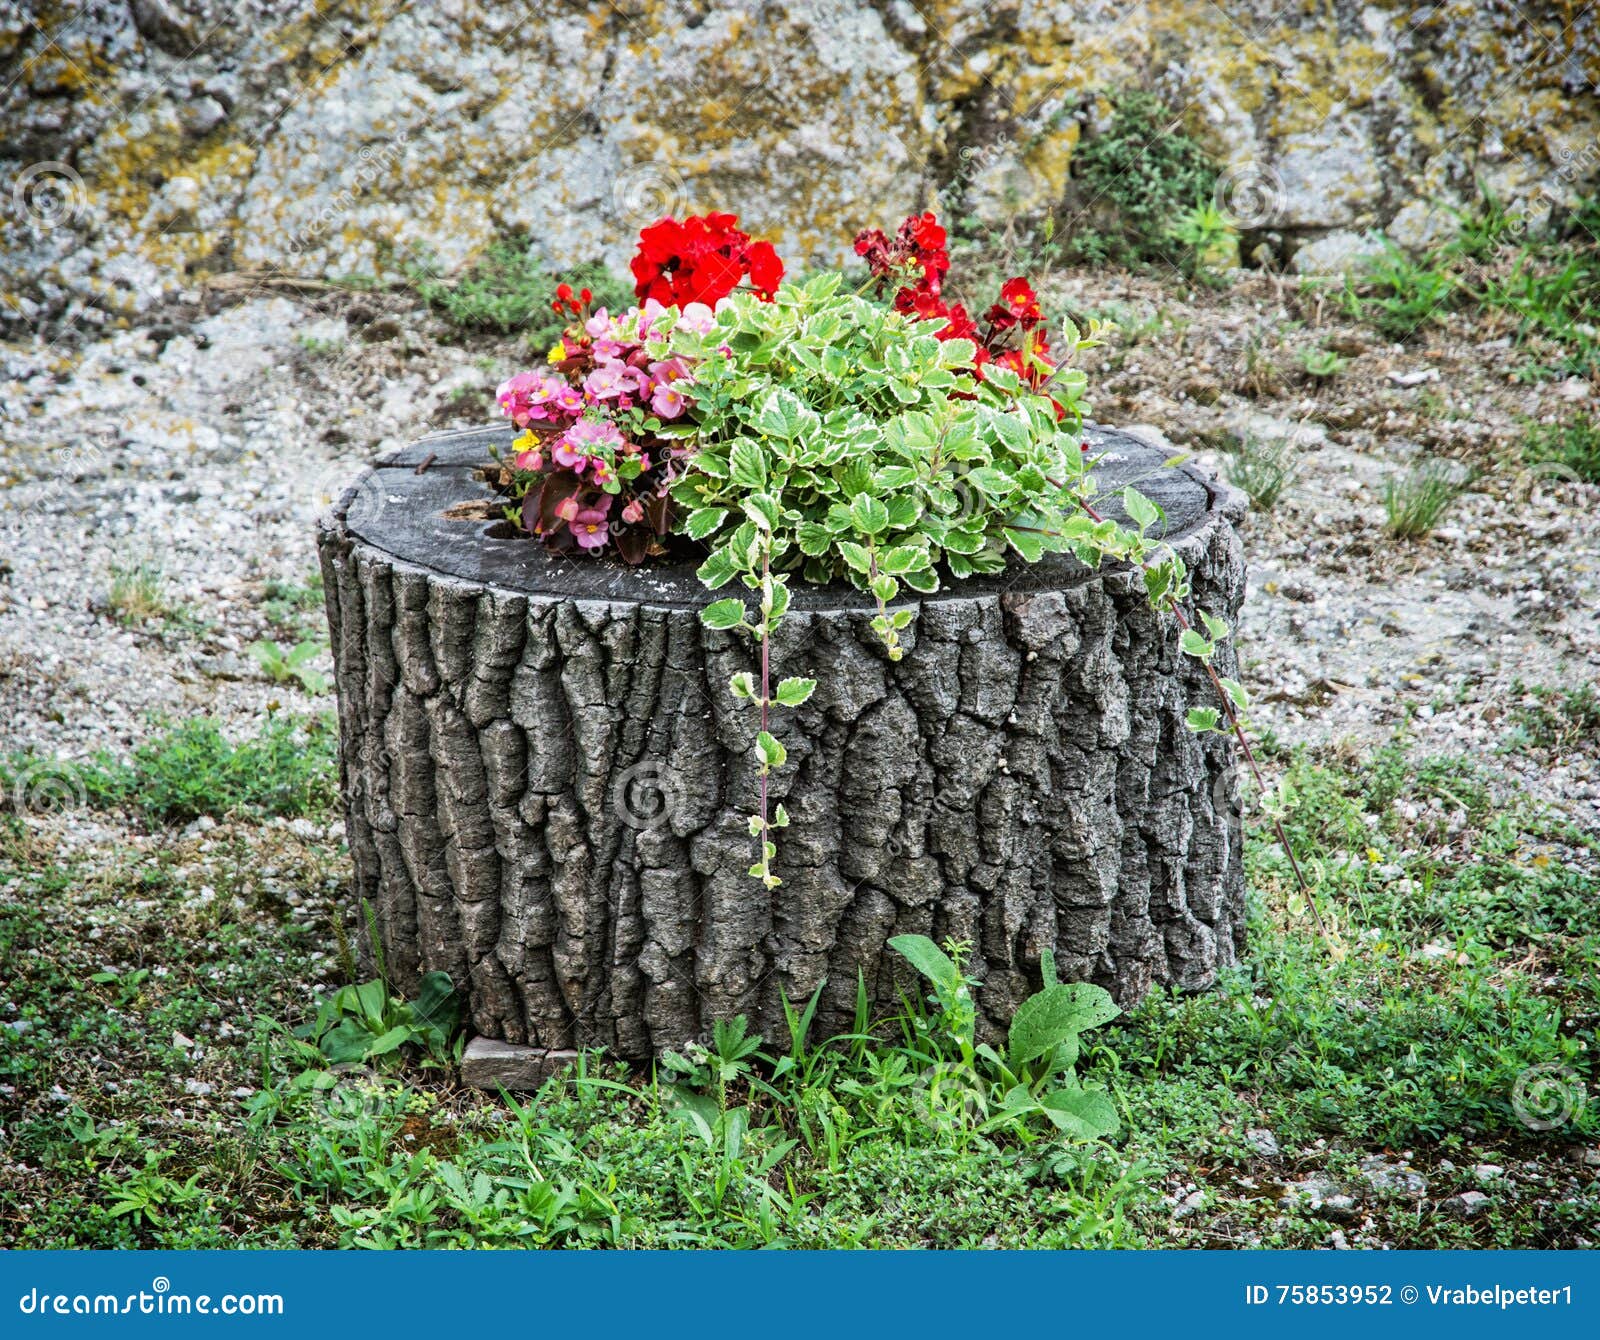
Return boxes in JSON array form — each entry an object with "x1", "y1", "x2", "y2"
[{"x1": 408, "y1": 238, "x2": 634, "y2": 352}]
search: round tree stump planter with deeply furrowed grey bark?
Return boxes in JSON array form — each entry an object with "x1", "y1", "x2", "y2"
[{"x1": 318, "y1": 429, "x2": 1245, "y2": 1084}]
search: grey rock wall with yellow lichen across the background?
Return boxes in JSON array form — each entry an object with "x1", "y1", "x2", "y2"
[{"x1": 0, "y1": 0, "x2": 1600, "y2": 329}]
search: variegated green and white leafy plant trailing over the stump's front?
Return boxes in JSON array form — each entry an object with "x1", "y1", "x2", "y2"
[{"x1": 662, "y1": 273, "x2": 1113, "y2": 887}]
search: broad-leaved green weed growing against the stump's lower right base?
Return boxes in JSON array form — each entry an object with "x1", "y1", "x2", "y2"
[{"x1": 890, "y1": 935, "x2": 1122, "y2": 1140}]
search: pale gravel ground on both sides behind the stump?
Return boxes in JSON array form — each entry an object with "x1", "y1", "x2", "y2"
[{"x1": 0, "y1": 272, "x2": 1600, "y2": 827}]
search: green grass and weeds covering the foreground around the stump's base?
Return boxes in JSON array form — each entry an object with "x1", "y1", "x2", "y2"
[{"x1": 0, "y1": 739, "x2": 1600, "y2": 1247}]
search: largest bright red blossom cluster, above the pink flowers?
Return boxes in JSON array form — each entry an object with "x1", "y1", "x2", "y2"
[{"x1": 630, "y1": 213, "x2": 784, "y2": 307}]
